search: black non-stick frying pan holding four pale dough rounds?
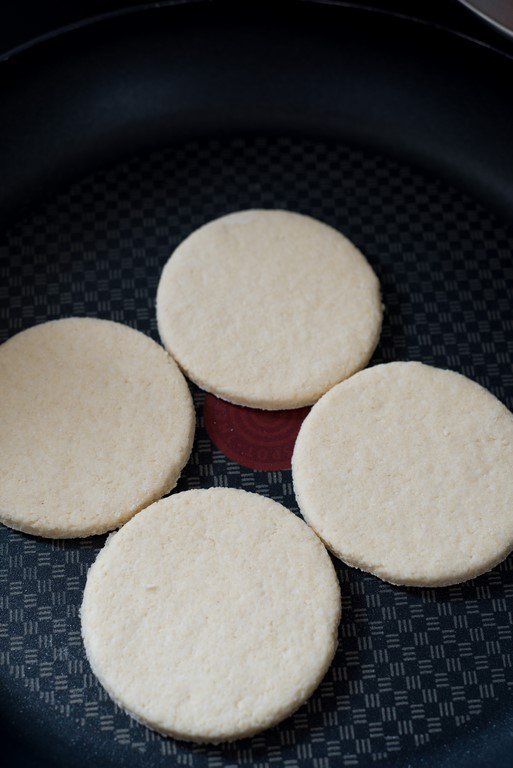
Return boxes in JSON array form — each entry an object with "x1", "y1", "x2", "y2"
[{"x1": 0, "y1": 2, "x2": 513, "y2": 768}]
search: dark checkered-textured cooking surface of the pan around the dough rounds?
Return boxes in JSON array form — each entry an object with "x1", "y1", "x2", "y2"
[{"x1": 0, "y1": 138, "x2": 513, "y2": 768}]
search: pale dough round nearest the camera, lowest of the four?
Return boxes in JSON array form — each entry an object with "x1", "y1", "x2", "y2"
[{"x1": 81, "y1": 488, "x2": 340, "y2": 743}]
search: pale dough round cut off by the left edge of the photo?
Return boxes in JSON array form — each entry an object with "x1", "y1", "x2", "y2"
[{"x1": 0, "y1": 318, "x2": 195, "y2": 538}]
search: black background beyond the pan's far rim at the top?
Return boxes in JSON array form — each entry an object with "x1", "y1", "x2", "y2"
[{"x1": 0, "y1": 0, "x2": 513, "y2": 57}]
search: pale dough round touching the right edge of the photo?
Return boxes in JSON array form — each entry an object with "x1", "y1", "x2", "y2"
[{"x1": 292, "y1": 362, "x2": 513, "y2": 587}]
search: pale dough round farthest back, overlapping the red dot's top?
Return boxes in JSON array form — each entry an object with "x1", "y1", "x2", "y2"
[{"x1": 157, "y1": 210, "x2": 382, "y2": 410}]
